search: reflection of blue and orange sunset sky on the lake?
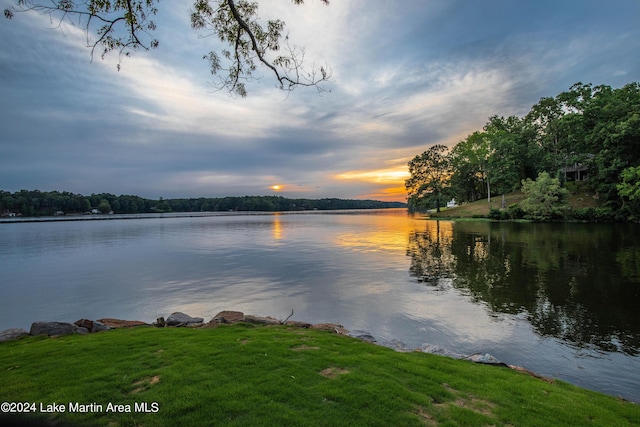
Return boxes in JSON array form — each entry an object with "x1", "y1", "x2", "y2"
[{"x1": 0, "y1": 212, "x2": 640, "y2": 399}]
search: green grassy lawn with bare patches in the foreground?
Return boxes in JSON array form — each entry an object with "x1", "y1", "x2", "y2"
[{"x1": 0, "y1": 324, "x2": 640, "y2": 427}]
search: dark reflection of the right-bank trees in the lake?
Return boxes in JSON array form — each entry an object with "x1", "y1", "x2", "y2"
[{"x1": 408, "y1": 222, "x2": 640, "y2": 355}]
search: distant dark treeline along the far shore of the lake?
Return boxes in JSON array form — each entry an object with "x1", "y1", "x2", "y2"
[{"x1": 0, "y1": 190, "x2": 406, "y2": 216}]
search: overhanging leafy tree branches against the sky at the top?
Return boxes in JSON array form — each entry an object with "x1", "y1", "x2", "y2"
[{"x1": 4, "y1": 0, "x2": 331, "y2": 97}]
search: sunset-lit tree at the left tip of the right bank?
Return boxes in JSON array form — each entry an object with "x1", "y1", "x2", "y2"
[{"x1": 405, "y1": 144, "x2": 451, "y2": 212}]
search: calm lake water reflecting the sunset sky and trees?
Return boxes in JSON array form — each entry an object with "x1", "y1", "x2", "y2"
[{"x1": 0, "y1": 210, "x2": 640, "y2": 402}]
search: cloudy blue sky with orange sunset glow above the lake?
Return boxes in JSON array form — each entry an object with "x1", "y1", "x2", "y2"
[{"x1": 0, "y1": 0, "x2": 640, "y2": 201}]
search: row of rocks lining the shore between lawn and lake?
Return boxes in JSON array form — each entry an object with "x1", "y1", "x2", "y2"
[{"x1": 0, "y1": 310, "x2": 520, "y2": 376}]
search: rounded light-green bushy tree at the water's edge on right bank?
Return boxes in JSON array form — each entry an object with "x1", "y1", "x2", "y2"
[{"x1": 520, "y1": 172, "x2": 569, "y2": 221}]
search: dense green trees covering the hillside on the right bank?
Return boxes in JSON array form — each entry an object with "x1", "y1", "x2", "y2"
[{"x1": 407, "y1": 82, "x2": 640, "y2": 220}]
